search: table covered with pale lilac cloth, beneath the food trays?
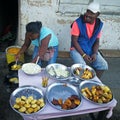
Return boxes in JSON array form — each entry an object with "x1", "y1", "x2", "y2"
[{"x1": 18, "y1": 69, "x2": 117, "y2": 120}]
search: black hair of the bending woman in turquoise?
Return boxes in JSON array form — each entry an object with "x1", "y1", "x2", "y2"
[{"x1": 26, "y1": 21, "x2": 42, "y2": 33}]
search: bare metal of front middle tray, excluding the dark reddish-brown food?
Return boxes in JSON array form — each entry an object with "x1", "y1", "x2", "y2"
[{"x1": 46, "y1": 82, "x2": 81, "y2": 111}]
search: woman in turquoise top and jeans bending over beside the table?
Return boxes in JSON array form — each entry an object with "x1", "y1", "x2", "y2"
[{"x1": 16, "y1": 21, "x2": 59, "y2": 66}]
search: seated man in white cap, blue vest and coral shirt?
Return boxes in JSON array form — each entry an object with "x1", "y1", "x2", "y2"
[{"x1": 70, "y1": 2, "x2": 108, "y2": 78}]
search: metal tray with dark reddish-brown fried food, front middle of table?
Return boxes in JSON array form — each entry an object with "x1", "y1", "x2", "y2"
[{"x1": 46, "y1": 82, "x2": 81, "y2": 111}]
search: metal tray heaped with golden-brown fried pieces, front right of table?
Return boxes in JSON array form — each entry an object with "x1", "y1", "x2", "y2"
[{"x1": 79, "y1": 81, "x2": 113, "y2": 105}]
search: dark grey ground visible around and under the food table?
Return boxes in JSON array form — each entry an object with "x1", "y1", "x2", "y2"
[{"x1": 0, "y1": 52, "x2": 120, "y2": 120}]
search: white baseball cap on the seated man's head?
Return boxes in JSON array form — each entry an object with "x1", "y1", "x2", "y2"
[{"x1": 87, "y1": 2, "x2": 100, "y2": 13}]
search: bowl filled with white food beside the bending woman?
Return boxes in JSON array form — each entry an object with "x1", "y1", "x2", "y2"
[{"x1": 22, "y1": 63, "x2": 41, "y2": 75}]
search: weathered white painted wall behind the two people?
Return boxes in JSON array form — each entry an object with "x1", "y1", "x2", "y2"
[{"x1": 17, "y1": 0, "x2": 120, "y2": 51}]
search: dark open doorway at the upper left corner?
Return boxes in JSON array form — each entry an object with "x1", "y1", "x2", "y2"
[{"x1": 0, "y1": 0, "x2": 18, "y2": 51}]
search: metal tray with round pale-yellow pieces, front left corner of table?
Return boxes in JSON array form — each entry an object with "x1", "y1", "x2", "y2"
[{"x1": 9, "y1": 86, "x2": 46, "y2": 115}]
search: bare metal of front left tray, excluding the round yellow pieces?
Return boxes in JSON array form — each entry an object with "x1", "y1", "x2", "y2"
[{"x1": 9, "y1": 85, "x2": 46, "y2": 115}]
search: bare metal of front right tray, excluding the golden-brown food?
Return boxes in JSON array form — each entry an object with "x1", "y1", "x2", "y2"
[{"x1": 79, "y1": 81, "x2": 113, "y2": 105}]
